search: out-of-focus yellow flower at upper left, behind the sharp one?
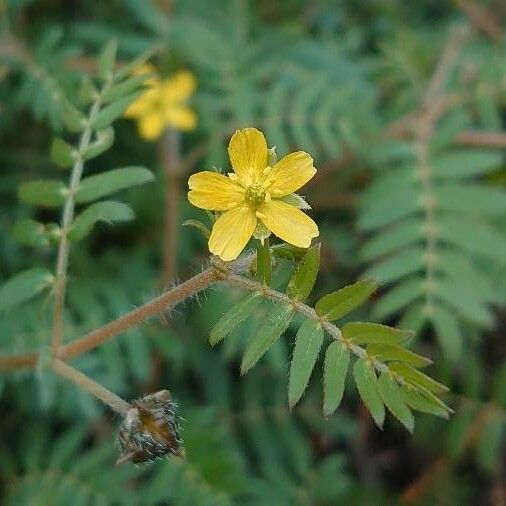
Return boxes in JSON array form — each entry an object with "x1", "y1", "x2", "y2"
[{"x1": 124, "y1": 65, "x2": 197, "y2": 141}]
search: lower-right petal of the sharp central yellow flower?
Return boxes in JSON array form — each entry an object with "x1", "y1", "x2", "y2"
[{"x1": 257, "y1": 200, "x2": 319, "y2": 248}]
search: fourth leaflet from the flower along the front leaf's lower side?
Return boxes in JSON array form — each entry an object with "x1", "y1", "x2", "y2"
[{"x1": 323, "y1": 341, "x2": 350, "y2": 416}]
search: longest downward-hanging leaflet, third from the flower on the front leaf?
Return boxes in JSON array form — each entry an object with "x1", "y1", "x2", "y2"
[{"x1": 288, "y1": 319, "x2": 324, "y2": 408}]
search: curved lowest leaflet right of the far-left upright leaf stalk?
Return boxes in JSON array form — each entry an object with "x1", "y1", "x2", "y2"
[{"x1": 68, "y1": 200, "x2": 134, "y2": 241}]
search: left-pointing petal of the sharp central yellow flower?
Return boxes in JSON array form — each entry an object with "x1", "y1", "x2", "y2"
[{"x1": 188, "y1": 171, "x2": 244, "y2": 211}]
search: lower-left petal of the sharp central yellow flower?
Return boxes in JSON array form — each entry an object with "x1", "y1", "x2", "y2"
[{"x1": 209, "y1": 206, "x2": 257, "y2": 262}]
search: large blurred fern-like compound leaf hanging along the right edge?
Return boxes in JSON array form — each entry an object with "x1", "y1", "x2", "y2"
[{"x1": 359, "y1": 35, "x2": 506, "y2": 362}]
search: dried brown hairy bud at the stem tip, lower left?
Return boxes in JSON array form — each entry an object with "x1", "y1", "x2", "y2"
[{"x1": 117, "y1": 390, "x2": 185, "y2": 464}]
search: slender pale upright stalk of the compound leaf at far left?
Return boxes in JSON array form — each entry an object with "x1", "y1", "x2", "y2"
[{"x1": 51, "y1": 78, "x2": 112, "y2": 357}]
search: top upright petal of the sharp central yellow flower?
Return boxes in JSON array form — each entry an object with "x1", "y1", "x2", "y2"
[{"x1": 228, "y1": 128, "x2": 267, "y2": 186}]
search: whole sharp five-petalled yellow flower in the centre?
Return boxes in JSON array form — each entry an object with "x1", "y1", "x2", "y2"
[{"x1": 188, "y1": 128, "x2": 319, "y2": 261}]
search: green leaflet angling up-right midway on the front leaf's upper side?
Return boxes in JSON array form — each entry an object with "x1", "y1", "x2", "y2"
[{"x1": 315, "y1": 280, "x2": 377, "y2": 321}]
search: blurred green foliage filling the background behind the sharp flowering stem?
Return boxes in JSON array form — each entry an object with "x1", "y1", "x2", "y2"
[{"x1": 0, "y1": 0, "x2": 506, "y2": 505}]
